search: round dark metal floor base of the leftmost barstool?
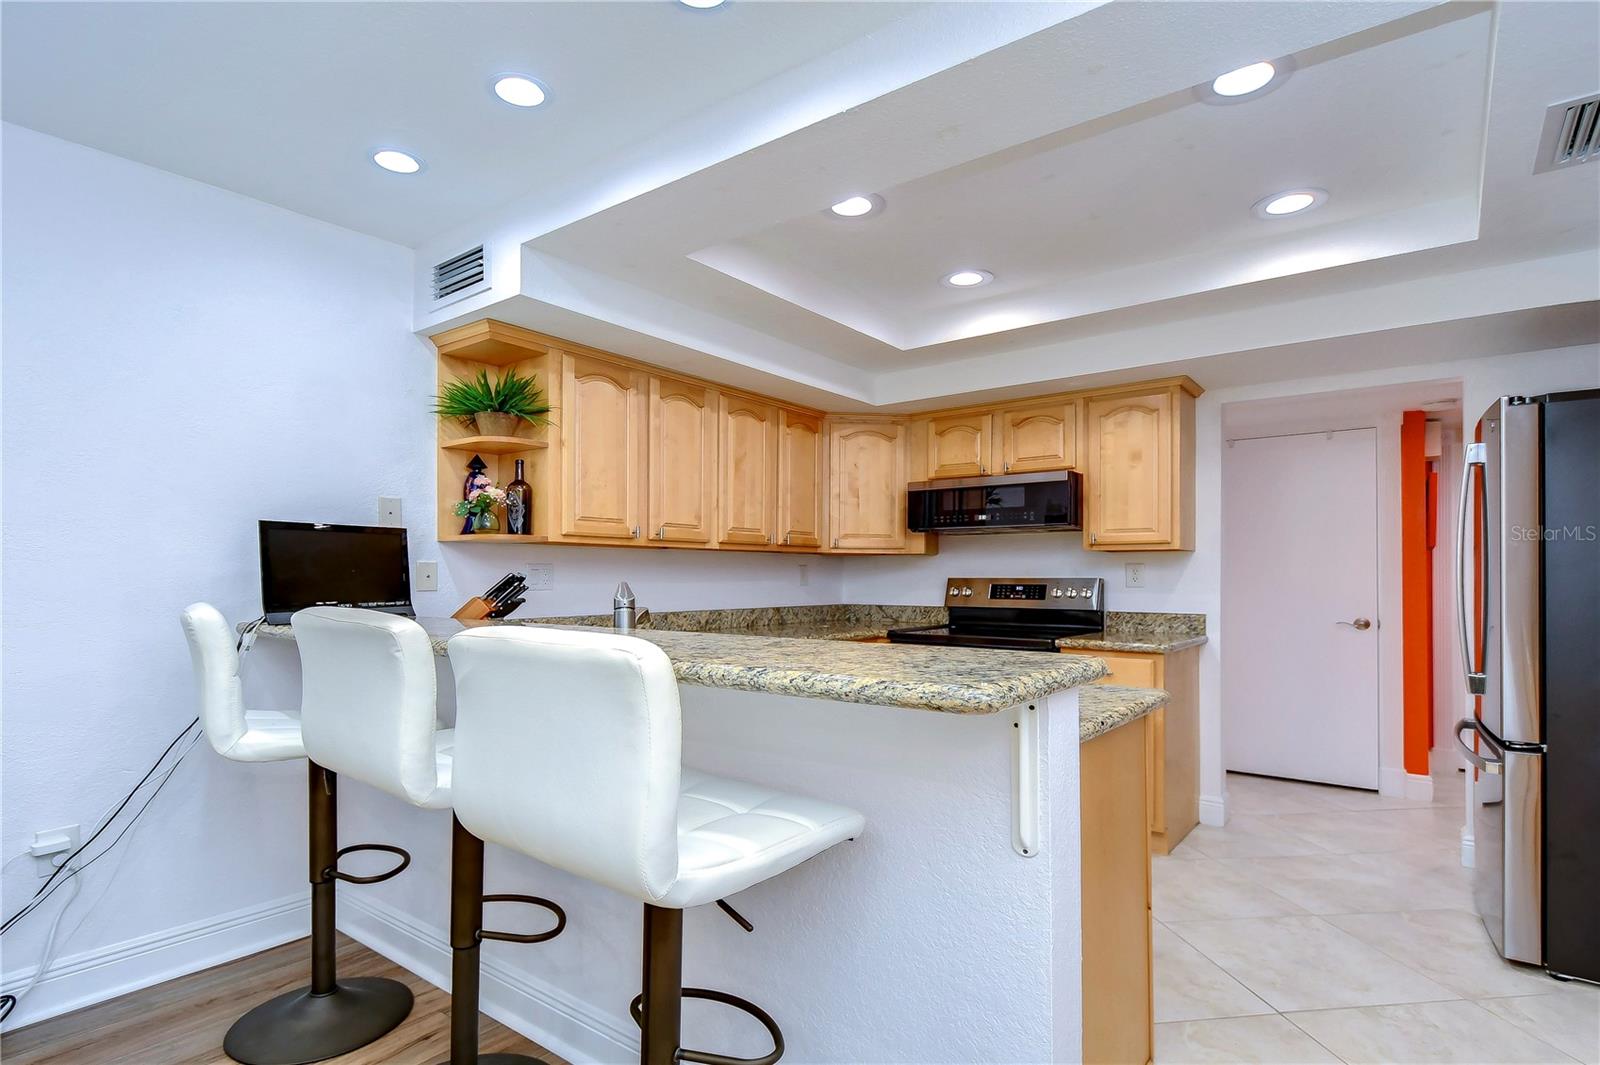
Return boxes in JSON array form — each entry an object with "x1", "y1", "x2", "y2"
[{"x1": 222, "y1": 977, "x2": 411, "y2": 1065}]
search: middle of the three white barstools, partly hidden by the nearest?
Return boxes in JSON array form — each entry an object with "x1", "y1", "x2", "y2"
[{"x1": 290, "y1": 606, "x2": 566, "y2": 1065}]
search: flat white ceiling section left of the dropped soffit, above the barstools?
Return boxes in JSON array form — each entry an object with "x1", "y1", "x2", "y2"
[{"x1": 0, "y1": 0, "x2": 928, "y2": 245}]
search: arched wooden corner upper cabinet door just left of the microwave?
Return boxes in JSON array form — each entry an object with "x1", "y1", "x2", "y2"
[{"x1": 827, "y1": 419, "x2": 907, "y2": 552}]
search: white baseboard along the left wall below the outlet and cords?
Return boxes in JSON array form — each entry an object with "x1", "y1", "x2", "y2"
[{"x1": 0, "y1": 892, "x2": 310, "y2": 1031}]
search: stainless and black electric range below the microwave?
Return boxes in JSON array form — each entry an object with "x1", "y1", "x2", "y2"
[{"x1": 888, "y1": 577, "x2": 1106, "y2": 652}]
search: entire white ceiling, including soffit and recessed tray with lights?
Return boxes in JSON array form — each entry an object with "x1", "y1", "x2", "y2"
[{"x1": 0, "y1": 0, "x2": 1600, "y2": 409}]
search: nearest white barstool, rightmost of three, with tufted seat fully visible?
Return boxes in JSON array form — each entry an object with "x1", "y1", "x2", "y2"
[{"x1": 450, "y1": 627, "x2": 866, "y2": 1065}]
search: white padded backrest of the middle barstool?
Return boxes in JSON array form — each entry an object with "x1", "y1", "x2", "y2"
[{"x1": 290, "y1": 606, "x2": 438, "y2": 806}]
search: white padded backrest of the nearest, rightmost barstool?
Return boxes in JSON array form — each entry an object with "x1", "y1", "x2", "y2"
[{"x1": 450, "y1": 625, "x2": 682, "y2": 902}]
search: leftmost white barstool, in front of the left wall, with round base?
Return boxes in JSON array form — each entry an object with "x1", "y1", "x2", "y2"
[{"x1": 182, "y1": 603, "x2": 411, "y2": 1065}]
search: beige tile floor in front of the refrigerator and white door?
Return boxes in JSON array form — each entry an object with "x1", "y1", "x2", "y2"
[{"x1": 1152, "y1": 772, "x2": 1600, "y2": 1065}]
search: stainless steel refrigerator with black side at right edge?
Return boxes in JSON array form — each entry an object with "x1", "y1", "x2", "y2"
[{"x1": 1456, "y1": 390, "x2": 1600, "y2": 980}]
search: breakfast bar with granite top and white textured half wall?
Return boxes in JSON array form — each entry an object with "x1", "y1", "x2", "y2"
[{"x1": 246, "y1": 617, "x2": 1166, "y2": 1063}]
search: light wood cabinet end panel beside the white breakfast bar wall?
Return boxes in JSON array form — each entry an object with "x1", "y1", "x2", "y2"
[{"x1": 1078, "y1": 712, "x2": 1160, "y2": 1065}]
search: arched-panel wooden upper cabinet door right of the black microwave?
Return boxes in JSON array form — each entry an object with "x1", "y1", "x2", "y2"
[{"x1": 1083, "y1": 389, "x2": 1178, "y2": 548}]
